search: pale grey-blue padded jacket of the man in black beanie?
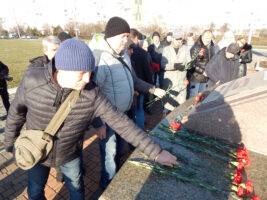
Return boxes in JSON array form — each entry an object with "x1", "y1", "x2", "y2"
[{"x1": 89, "y1": 36, "x2": 154, "y2": 112}]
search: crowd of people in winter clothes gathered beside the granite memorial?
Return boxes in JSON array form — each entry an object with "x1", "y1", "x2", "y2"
[{"x1": 1, "y1": 17, "x2": 252, "y2": 200}]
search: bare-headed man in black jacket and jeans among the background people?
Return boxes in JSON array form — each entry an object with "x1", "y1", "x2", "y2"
[{"x1": 188, "y1": 30, "x2": 215, "y2": 97}]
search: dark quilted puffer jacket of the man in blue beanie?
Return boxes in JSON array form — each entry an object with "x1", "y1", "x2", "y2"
[{"x1": 5, "y1": 62, "x2": 161, "y2": 166}]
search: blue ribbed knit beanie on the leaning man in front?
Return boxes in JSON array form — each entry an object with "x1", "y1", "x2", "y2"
[{"x1": 55, "y1": 39, "x2": 95, "y2": 71}]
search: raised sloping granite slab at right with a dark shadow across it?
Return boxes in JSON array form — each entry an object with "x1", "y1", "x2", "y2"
[{"x1": 183, "y1": 71, "x2": 267, "y2": 155}]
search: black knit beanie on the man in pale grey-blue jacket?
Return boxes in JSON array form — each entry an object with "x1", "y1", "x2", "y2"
[{"x1": 105, "y1": 17, "x2": 130, "y2": 38}]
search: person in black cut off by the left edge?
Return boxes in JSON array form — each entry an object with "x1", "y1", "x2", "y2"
[{"x1": 0, "y1": 61, "x2": 11, "y2": 116}]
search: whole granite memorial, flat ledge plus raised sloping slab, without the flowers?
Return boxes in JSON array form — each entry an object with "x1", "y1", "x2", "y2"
[{"x1": 99, "y1": 73, "x2": 267, "y2": 200}]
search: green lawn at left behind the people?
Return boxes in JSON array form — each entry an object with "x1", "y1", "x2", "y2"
[{"x1": 0, "y1": 39, "x2": 43, "y2": 88}]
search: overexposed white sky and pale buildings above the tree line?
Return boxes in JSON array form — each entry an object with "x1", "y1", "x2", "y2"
[{"x1": 0, "y1": 0, "x2": 267, "y2": 29}]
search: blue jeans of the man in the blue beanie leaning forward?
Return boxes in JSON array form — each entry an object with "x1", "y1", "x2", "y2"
[{"x1": 27, "y1": 156, "x2": 84, "y2": 200}]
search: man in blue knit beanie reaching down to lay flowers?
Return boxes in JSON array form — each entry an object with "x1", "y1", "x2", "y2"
[{"x1": 5, "y1": 39, "x2": 178, "y2": 200}]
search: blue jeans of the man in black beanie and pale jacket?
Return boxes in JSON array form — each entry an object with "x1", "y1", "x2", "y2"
[{"x1": 98, "y1": 124, "x2": 125, "y2": 188}]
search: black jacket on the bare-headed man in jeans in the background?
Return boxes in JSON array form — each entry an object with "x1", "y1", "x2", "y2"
[{"x1": 189, "y1": 36, "x2": 215, "y2": 83}]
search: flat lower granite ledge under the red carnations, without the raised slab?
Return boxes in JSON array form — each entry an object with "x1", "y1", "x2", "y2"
[{"x1": 100, "y1": 83, "x2": 267, "y2": 200}]
